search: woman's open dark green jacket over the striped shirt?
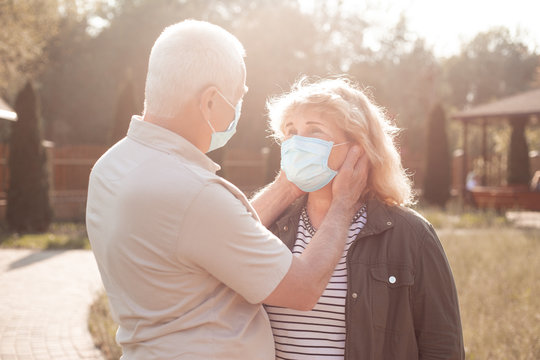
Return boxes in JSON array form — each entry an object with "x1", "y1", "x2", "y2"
[{"x1": 270, "y1": 197, "x2": 465, "y2": 360}]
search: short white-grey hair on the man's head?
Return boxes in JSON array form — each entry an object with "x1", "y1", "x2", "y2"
[{"x1": 144, "y1": 20, "x2": 245, "y2": 118}]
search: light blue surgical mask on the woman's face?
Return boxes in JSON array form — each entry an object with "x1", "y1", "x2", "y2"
[{"x1": 281, "y1": 135, "x2": 346, "y2": 192}]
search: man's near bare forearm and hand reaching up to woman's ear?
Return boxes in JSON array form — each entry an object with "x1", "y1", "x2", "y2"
[{"x1": 263, "y1": 146, "x2": 367, "y2": 310}]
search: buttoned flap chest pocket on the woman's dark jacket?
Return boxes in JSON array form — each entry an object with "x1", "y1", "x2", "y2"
[{"x1": 370, "y1": 264, "x2": 414, "y2": 334}]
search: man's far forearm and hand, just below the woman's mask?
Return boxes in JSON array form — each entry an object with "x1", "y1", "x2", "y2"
[{"x1": 250, "y1": 171, "x2": 304, "y2": 227}]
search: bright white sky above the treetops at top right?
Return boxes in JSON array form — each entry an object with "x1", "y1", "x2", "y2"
[{"x1": 300, "y1": 0, "x2": 540, "y2": 56}]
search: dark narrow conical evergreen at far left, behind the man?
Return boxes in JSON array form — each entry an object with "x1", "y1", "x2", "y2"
[{"x1": 6, "y1": 82, "x2": 52, "y2": 232}]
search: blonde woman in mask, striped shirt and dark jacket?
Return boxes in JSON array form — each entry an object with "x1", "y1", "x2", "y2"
[{"x1": 266, "y1": 78, "x2": 464, "y2": 360}]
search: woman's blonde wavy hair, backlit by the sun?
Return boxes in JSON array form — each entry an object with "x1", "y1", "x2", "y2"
[{"x1": 266, "y1": 77, "x2": 414, "y2": 205}]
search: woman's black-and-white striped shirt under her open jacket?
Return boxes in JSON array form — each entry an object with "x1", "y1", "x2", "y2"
[{"x1": 266, "y1": 207, "x2": 366, "y2": 360}]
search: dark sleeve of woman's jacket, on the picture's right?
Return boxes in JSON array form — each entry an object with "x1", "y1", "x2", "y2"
[{"x1": 411, "y1": 225, "x2": 465, "y2": 360}]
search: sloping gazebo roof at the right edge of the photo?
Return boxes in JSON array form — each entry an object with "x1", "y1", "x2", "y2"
[{"x1": 452, "y1": 88, "x2": 540, "y2": 121}]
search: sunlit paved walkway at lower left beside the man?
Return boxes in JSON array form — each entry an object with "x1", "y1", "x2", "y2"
[{"x1": 0, "y1": 250, "x2": 103, "y2": 360}]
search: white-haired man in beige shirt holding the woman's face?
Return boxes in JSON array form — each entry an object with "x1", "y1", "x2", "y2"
[{"x1": 86, "y1": 20, "x2": 365, "y2": 360}]
